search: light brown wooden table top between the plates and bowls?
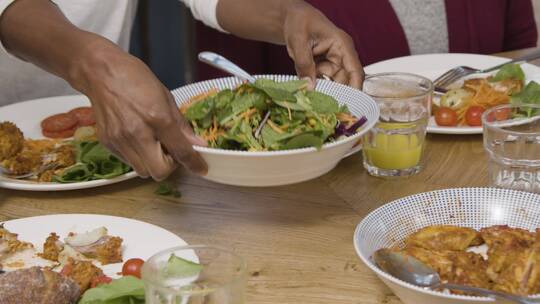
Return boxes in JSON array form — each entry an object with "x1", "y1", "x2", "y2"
[{"x1": 0, "y1": 50, "x2": 538, "y2": 304}]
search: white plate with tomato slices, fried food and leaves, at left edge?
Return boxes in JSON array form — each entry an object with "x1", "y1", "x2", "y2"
[{"x1": 0, "y1": 95, "x2": 137, "y2": 191}]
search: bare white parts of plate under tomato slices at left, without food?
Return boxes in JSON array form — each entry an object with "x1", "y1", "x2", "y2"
[{"x1": 0, "y1": 95, "x2": 137, "y2": 191}]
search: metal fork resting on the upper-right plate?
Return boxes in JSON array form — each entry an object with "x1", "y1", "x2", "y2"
[{"x1": 433, "y1": 51, "x2": 540, "y2": 93}]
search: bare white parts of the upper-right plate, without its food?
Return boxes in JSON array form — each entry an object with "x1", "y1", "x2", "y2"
[{"x1": 365, "y1": 54, "x2": 540, "y2": 134}]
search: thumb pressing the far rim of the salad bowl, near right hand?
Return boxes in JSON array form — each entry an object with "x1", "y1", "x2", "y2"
[{"x1": 287, "y1": 36, "x2": 317, "y2": 89}]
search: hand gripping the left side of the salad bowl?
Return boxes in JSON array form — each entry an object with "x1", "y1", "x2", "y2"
[{"x1": 72, "y1": 46, "x2": 207, "y2": 180}]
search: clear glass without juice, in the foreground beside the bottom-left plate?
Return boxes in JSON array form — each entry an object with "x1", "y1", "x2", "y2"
[{"x1": 142, "y1": 245, "x2": 246, "y2": 304}]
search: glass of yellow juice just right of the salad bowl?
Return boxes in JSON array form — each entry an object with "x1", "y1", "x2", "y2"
[{"x1": 362, "y1": 73, "x2": 433, "y2": 177}]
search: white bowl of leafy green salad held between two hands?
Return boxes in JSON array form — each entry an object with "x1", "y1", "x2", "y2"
[{"x1": 172, "y1": 75, "x2": 379, "y2": 186}]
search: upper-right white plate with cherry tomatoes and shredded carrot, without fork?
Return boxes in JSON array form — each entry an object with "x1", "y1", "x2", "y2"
[{"x1": 366, "y1": 54, "x2": 540, "y2": 134}]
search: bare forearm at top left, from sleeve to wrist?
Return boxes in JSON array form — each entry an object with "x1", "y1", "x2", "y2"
[{"x1": 0, "y1": 0, "x2": 122, "y2": 90}]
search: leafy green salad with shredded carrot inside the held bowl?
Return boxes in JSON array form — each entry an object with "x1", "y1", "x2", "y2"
[{"x1": 181, "y1": 79, "x2": 366, "y2": 151}]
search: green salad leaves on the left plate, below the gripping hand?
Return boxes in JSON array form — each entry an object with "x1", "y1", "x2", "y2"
[{"x1": 53, "y1": 141, "x2": 131, "y2": 183}]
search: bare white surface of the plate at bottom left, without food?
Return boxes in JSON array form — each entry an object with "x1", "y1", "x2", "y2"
[{"x1": 0, "y1": 214, "x2": 192, "y2": 277}]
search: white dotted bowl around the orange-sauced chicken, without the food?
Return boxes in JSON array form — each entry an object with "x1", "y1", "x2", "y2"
[{"x1": 354, "y1": 188, "x2": 540, "y2": 304}]
